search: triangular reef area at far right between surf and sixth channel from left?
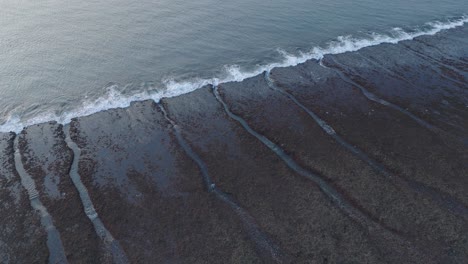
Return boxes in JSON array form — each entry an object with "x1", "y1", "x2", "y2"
[{"x1": 323, "y1": 27, "x2": 468, "y2": 140}]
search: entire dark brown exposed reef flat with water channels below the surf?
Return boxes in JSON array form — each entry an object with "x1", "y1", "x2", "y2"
[{"x1": 0, "y1": 26, "x2": 468, "y2": 263}]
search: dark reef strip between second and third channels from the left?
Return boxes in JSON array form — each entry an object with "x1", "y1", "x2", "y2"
[{"x1": 71, "y1": 101, "x2": 260, "y2": 263}]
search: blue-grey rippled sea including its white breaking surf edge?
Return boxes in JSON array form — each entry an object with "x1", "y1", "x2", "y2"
[{"x1": 0, "y1": 0, "x2": 468, "y2": 132}]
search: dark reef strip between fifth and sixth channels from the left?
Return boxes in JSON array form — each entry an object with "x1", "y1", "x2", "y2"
[{"x1": 271, "y1": 57, "x2": 468, "y2": 210}]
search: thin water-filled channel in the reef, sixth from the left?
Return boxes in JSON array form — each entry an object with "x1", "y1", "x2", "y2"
[{"x1": 325, "y1": 57, "x2": 439, "y2": 133}]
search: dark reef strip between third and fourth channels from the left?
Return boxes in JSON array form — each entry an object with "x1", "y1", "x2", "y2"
[{"x1": 164, "y1": 88, "x2": 392, "y2": 263}]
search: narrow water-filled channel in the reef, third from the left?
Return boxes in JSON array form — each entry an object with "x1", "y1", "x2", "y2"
[{"x1": 158, "y1": 103, "x2": 287, "y2": 263}]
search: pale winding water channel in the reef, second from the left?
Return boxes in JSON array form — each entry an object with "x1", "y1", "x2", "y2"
[{"x1": 65, "y1": 129, "x2": 129, "y2": 264}]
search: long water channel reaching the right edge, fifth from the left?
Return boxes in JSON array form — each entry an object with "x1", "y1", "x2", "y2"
[{"x1": 264, "y1": 72, "x2": 468, "y2": 217}]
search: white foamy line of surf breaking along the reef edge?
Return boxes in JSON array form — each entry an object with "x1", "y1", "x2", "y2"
[{"x1": 0, "y1": 16, "x2": 468, "y2": 133}]
